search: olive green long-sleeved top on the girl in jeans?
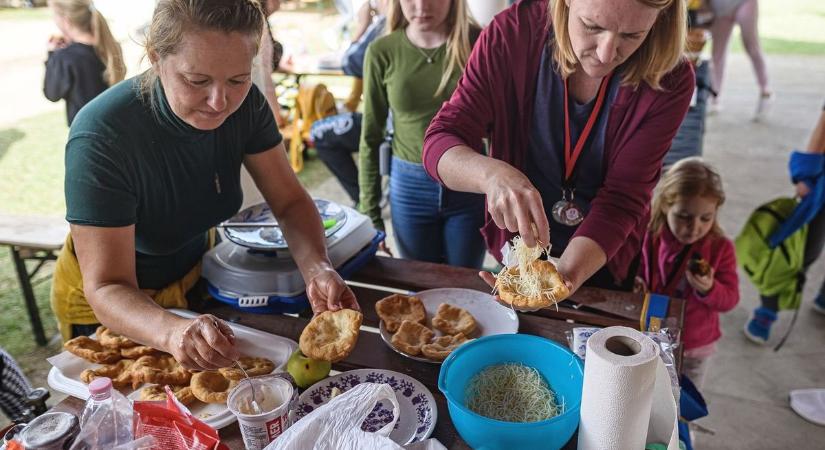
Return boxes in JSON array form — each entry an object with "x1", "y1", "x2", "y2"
[{"x1": 358, "y1": 29, "x2": 461, "y2": 230}]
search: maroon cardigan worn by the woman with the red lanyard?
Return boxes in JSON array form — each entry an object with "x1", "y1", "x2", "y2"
[{"x1": 423, "y1": 0, "x2": 695, "y2": 280}]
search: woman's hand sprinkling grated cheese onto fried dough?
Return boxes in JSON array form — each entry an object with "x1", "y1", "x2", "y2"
[{"x1": 484, "y1": 164, "x2": 550, "y2": 247}]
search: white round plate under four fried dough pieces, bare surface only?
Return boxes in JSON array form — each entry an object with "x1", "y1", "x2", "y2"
[{"x1": 379, "y1": 288, "x2": 519, "y2": 364}]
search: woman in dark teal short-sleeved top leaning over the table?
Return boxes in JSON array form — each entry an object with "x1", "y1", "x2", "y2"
[{"x1": 52, "y1": 0, "x2": 358, "y2": 370}]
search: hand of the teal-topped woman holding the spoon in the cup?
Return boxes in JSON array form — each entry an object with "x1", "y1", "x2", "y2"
[{"x1": 163, "y1": 314, "x2": 240, "y2": 370}]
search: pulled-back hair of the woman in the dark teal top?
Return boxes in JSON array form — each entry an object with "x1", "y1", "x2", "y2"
[{"x1": 140, "y1": 0, "x2": 265, "y2": 100}]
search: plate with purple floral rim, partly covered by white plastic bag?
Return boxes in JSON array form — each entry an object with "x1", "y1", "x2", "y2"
[{"x1": 294, "y1": 369, "x2": 438, "y2": 445}]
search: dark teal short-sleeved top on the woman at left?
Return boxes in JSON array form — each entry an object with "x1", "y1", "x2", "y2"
[{"x1": 65, "y1": 77, "x2": 282, "y2": 289}]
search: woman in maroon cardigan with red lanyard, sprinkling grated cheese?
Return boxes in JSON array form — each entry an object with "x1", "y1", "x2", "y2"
[{"x1": 423, "y1": 0, "x2": 694, "y2": 292}]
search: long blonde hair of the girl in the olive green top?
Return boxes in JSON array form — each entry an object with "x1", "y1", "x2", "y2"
[{"x1": 387, "y1": 0, "x2": 481, "y2": 97}]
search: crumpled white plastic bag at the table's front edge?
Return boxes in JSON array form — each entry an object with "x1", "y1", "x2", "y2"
[{"x1": 264, "y1": 383, "x2": 444, "y2": 450}]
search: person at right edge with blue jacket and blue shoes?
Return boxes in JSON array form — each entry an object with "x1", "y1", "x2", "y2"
[{"x1": 745, "y1": 100, "x2": 825, "y2": 345}]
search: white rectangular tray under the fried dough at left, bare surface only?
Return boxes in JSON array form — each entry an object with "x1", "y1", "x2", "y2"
[{"x1": 48, "y1": 309, "x2": 298, "y2": 429}]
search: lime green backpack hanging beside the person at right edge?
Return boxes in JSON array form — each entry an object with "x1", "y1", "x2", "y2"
[{"x1": 736, "y1": 198, "x2": 808, "y2": 309}]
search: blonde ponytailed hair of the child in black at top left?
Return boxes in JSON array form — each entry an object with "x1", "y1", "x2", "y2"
[{"x1": 49, "y1": 0, "x2": 126, "y2": 86}]
